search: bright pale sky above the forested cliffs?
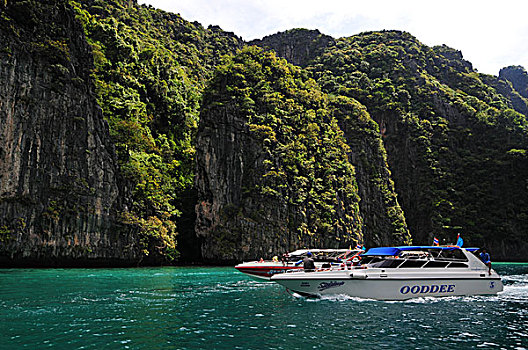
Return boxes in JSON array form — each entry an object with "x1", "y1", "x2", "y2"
[{"x1": 138, "y1": 0, "x2": 528, "y2": 75}]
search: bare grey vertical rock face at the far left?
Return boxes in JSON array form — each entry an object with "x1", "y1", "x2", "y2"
[{"x1": 0, "y1": 1, "x2": 140, "y2": 266}]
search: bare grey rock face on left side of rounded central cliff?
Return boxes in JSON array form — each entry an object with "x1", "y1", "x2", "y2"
[{"x1": 196, "y1": 102, "x2": 288, "y2": 262}]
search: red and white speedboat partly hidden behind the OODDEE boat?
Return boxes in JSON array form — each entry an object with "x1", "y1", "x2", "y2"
[{"x1": 235, "y1": 249, "x2": 363, "y2": 280}]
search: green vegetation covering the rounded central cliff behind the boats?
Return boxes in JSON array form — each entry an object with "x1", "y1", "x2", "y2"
[{"x1": 198, "y1": 47, "x2": 363, "y2": 258}]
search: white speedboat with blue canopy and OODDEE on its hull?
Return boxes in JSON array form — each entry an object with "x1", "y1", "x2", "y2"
[{"x1": 271, "y1": 246, "x2": 503, "y2": 300}]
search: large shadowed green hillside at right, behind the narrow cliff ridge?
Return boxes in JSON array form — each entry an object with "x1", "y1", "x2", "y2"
[{"x1": 308, "y1": 31, "x2": 528, "y2": 250}]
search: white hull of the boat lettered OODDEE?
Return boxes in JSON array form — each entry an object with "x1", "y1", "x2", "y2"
[{"x1": 271, "y1": 269, "x2": 503, "y2": 300}]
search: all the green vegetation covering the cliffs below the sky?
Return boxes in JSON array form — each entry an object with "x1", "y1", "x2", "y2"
[{"x1": 0, "y1": 0, "x2": 528, "y2": 262}]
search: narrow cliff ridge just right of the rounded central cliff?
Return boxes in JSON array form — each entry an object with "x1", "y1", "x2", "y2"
[{"x1": 332, "y1": 96, "x2": 411, "y2": 247}]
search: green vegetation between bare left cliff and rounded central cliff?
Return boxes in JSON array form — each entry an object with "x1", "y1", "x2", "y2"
[{"x1": 70, "y1": 0, "x2": 240, "y2": 260}]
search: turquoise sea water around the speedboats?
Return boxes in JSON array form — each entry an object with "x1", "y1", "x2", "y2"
[{"x1": 0, "y1": 264, "x2": 528, "y2": 349}]
